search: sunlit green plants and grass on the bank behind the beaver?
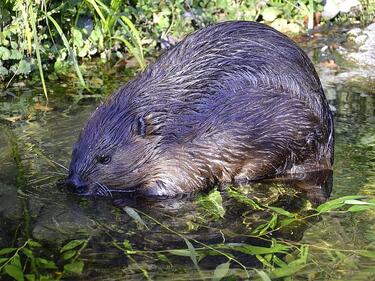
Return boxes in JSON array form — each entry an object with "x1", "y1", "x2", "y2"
[{"x1": 0, "y1": 0, "x2": 373, "y2": 98}]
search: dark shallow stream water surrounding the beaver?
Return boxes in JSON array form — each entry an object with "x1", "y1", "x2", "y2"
[{"x1": 0, "y1": 31, "x2": 375, "y2": 280}]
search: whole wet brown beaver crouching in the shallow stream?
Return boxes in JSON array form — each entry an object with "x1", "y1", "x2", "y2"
[{"x1": 66, "y1": 21, "x2": 333, "y2": 196}]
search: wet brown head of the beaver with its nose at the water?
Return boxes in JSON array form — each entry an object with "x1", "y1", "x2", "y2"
[{"x1": 66, "y1": 99, "x2": 158, "y2": 196}]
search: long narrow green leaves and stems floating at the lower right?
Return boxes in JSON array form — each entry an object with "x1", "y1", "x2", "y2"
[{"x1": 114, "y1": 194, "x2": 375, "y2": 280}]
